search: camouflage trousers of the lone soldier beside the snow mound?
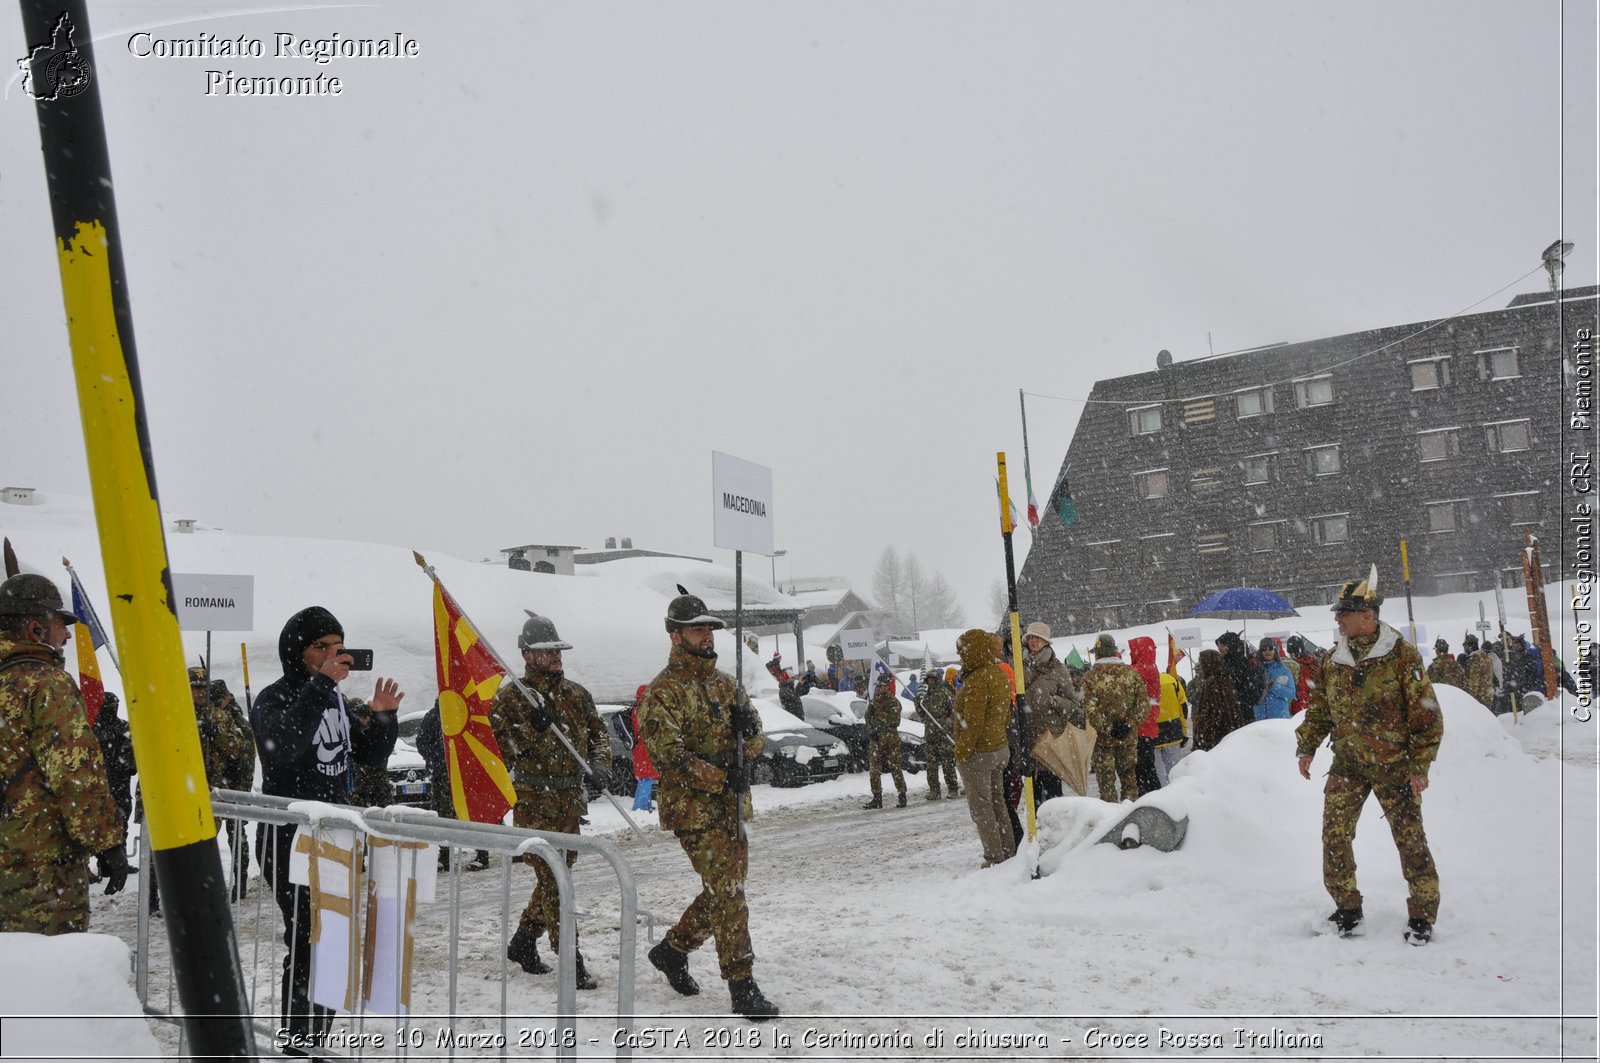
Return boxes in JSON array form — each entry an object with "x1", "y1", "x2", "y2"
[{"x1": 1322, "y1": 770, "x2": 1438, "y2": 922}]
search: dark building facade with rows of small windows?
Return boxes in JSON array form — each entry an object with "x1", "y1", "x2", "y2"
[{"x1": 1018, "y1": 287, "x2": 1600, "y2": 631}]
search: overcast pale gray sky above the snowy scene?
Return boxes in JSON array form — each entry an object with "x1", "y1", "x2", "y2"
[{"x1": 0, "y1": 0, "x2": 1597, "y2": 621}]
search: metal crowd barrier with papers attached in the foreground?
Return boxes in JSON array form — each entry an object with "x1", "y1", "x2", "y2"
[{"x1": 134, "y1": 789, "x2": 640, "y2": 1060}]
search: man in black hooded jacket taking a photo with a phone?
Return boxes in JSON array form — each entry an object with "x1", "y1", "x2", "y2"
[{"x1": 250, "y1": 605, "x2": 405, "y2": 1055}]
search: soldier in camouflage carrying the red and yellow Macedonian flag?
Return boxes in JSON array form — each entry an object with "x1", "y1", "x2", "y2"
[{"x1": 490, "y1": 612, "x2": 611, "y2": 989}]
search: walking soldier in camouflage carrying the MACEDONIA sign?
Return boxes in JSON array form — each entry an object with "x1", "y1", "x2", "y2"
[{"x1": 638, "y1": 594, "x2": 778, "y2": 1021}]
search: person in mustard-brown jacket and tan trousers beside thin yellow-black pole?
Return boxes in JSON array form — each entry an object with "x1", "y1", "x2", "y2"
[{"x1": 954, "y1": 628, "x2": 1016, "y2": 868}]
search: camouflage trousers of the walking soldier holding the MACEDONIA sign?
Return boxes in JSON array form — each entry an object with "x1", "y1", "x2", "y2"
[{"x1": 666, "y1": 824, "x2": 755, "y2": 981}]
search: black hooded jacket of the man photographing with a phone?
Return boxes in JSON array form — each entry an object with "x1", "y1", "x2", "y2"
[{"x1": 250, "y1": 605, "x2": 398, "y2": 805}]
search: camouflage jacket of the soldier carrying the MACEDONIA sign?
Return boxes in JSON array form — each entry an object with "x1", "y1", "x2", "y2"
[{"x1": 638, "y1": 647, "x2": 766, "y2": 831}]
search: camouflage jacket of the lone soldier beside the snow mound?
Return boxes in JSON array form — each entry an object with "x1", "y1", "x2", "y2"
[{"x1": 1294, "y1": 621, "x2": 1445, "y2": 775}]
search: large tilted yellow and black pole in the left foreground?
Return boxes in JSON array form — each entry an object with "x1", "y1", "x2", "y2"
[{"x1": 21, "y1": 0, "x2": 256, "y2": 1060}]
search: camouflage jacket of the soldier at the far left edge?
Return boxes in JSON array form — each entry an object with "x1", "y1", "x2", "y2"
[{"x1": 0, "y1": 636, "x2": 126, "y2": 868}]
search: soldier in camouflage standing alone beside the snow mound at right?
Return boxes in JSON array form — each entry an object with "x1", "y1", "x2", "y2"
[{"x1": 1294, "y1": 567, "x2": 1445, "y2": 945}]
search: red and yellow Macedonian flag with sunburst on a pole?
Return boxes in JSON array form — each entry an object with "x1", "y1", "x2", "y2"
[{"x1": 434, "y1": 581, "x2": 517, "y2": 823}]
